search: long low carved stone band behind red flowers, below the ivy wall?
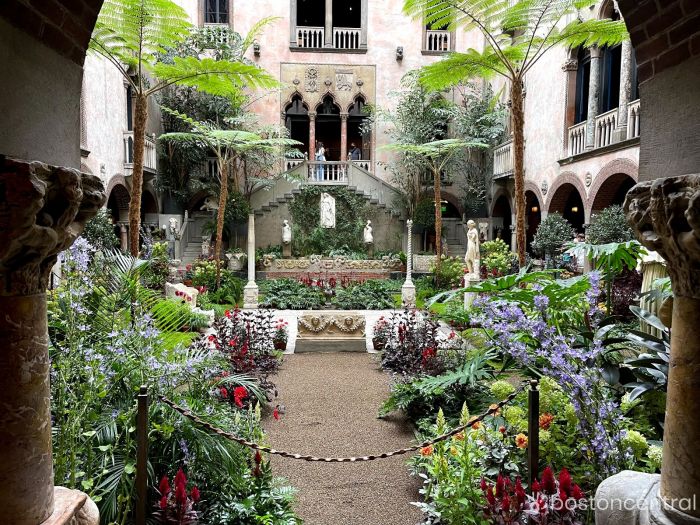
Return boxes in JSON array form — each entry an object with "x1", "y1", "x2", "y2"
[{"x1": 262, "y1": 254, "x2": 403, "y2": 273}]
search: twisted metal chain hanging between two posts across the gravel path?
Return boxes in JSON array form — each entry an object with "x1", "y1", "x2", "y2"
[{"x1": 158, "y1": 382, "x2": 528, "y2": 463}]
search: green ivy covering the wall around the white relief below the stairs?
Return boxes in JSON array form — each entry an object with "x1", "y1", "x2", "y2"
[{"x1": 289, "y1": 186, "x2": 375, "y2": 256}]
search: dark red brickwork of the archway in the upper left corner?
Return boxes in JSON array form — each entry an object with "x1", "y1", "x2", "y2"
[{"x1": 0, "y1": 0, "x2": 103, "y2": 65}]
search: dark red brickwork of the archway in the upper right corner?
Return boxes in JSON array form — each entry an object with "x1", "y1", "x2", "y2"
[{"x1": 619, "y1": 0, "x2": 700, "y2": 82}]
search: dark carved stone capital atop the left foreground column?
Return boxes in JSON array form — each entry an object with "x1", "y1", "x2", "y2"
[{"x1": 0, "y1": 157, "x2": 106, "y2": 296}]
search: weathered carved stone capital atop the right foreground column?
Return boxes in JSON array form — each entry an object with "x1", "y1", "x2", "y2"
[{"x1": 625, "y1": 174, "x2": 700, "y2": 299}]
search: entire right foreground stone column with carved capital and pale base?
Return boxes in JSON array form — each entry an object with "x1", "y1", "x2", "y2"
[{"x1": 596, "y1": 174, "x2": 700, "y2": 525}]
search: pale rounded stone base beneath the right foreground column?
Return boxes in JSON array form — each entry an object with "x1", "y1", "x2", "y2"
[{"x1": 595, "y1": 470, "x2": 700, "y2": 525}]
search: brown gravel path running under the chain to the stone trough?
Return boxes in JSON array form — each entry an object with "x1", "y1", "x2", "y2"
[{"x1": 265, "y1": 352, "x2": 421, "y2": 525}]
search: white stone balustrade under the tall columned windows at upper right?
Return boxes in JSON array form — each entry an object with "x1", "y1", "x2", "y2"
[{"x1": 567, "y1": 100, "x2": 641, "y2": 157}]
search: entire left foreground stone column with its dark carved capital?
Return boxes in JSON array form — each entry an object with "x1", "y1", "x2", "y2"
[{"x1": 0, "y1": 156, "x2": 105, "y2": 525}]
